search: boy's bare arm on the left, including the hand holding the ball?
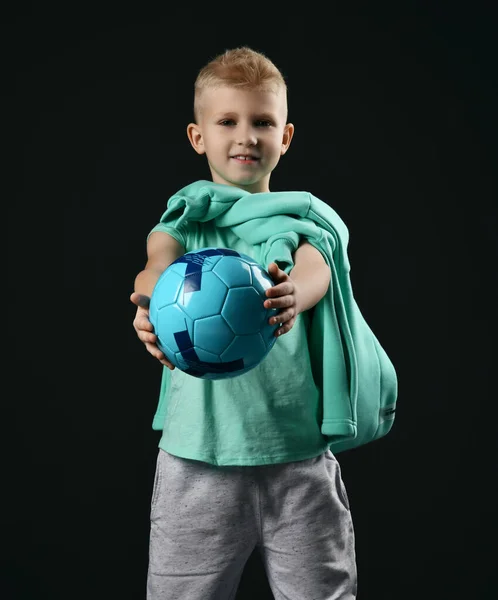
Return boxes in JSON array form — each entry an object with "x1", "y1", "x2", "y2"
[{"x1": 130, "y1": 231, "x2": 185, "y2": 369}]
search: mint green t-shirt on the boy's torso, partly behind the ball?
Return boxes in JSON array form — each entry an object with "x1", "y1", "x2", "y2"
[{"x1": 147, "y1": 221, "x2": 329, "y2": 465}]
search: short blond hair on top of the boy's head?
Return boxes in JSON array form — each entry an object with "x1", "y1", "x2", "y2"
[{"x1": 194, "y1": 46, "x2": 287, "y2": 121}]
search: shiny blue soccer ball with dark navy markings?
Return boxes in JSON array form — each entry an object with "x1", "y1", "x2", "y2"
[{"x1": 149, "y1": 248, "x2": 279, "y2": 379}]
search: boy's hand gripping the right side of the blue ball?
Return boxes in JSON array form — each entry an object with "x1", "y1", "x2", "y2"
[{"x1": 264, "y1": 263, "x2": 300, "y2": 336}]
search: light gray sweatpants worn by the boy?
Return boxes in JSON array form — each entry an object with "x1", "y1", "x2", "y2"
[{"x1": 147, "y1": 449, "x2": 356, "y2": 600}]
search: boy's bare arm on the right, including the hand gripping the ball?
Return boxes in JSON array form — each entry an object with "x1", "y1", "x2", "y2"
[{"x1": 265, "y1": 242, "x2": 331, "y2": 335}]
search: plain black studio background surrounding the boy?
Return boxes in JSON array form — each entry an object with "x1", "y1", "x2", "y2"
[{"x1": 4, "y1": 2, "x2": 498, "y2": 600}]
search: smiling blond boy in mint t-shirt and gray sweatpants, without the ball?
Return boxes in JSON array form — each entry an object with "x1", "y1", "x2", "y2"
[{"x1": 131, "y1": 47, "x2": 357, "y2": 600}]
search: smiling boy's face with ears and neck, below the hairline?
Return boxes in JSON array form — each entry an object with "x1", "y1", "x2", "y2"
[{"x1": 187, "y1": 87, "x2": 294, "y2": 193}]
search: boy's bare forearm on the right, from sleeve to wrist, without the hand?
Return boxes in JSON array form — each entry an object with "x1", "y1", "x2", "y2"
[{"x1": 289, "y1": 242, "x2": 330, "y2": 312}]
